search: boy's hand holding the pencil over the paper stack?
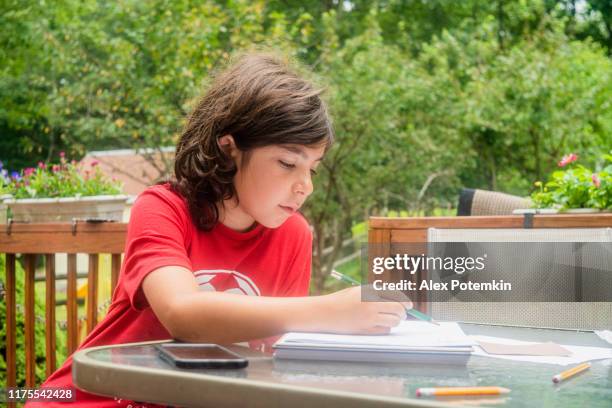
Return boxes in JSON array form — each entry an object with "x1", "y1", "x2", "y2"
[{"x1": 317, "y1": 285, "x2": 412, "y2": 334}]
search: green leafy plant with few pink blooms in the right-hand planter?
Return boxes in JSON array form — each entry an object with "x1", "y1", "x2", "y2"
[{"x1": 531, "y1": 152, "x2": 612, "y2": 210}]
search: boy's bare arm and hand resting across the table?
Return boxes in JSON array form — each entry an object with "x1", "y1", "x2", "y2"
[{"x1": 142, "y1": 266, "x2": 412, "y2": 344}]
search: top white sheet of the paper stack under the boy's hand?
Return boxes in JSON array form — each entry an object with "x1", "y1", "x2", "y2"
[{"x1": 282, "y1": 320, "x2": 476, "y2": 347}]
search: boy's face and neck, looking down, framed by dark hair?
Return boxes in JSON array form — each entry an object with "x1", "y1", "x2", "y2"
[{"x1": 220, "y1": 140, "x2": 325, "y2": 231}]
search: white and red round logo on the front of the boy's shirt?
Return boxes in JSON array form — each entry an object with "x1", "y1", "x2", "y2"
[{"x1": 193, "y1": 269, "x2": 261, "y2": 296}]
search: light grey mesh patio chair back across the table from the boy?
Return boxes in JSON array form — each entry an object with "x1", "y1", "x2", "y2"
[{"x1": 427, "y1": 228, "x2": 612, "y2": 330}]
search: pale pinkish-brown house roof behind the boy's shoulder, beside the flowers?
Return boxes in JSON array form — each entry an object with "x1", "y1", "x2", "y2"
[{"x1": 81, "y1": 146, "x2": 175, "y2": 196}]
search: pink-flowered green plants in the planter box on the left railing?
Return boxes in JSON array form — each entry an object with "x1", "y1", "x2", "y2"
[{"x1": 0, "y1": 152, "x2": 121, "y2": 198}]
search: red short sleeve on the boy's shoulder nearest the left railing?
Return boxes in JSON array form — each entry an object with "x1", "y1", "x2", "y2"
[{"x1": 120, "y1": 186, "x2": 192, "y2": 310}]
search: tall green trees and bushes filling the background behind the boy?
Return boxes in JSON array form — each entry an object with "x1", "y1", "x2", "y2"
[{"x1": 0, "y1": 0, "x2": 612, "y2": 291}]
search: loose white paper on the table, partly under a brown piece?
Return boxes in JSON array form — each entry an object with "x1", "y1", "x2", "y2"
[{"x1": 470, "y1": 336, "x2": 612, "y2": 365}]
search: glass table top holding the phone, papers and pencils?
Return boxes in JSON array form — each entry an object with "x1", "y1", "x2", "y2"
[{"x1": 82, "y1": 324, "x2": 612, "y2": 408}]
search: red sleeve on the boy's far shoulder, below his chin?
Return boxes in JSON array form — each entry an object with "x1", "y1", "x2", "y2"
[{"x1": 277, "y1": 215, "x2": 312, "y2": 297}]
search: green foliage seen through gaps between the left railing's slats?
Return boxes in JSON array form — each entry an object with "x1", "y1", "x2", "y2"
[{"x1": 0, "y1": 256, "x2": 67, "y2": 387}]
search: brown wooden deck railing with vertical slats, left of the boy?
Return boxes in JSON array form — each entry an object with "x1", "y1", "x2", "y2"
[{"x1": 0, "y1": 222, "x2": 127, "y2": 396}]
